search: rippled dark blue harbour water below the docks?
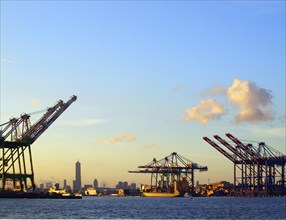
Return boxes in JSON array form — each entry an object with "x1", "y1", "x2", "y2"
[{"x1": 0, "y1": 197, "x2": 286, "y2": 219}]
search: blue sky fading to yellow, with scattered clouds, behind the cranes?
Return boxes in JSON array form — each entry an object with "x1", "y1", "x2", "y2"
[{"x1": 0, "y1": 0, "x2": 286, "y2": 187}]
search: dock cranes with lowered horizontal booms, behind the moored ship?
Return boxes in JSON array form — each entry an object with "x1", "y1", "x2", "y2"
[{"x1": 129, "y1": 152, "x2": 208, "y2": 195}]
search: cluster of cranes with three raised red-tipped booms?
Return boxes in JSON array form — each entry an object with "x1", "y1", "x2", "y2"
[{"x1": 203, "y1": 133, "x2": 286, "y2": 196}]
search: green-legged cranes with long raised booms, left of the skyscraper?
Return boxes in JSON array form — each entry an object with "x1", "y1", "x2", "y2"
[{"x1": 0, "y1": 95, "x2": 77, "y2": 192}]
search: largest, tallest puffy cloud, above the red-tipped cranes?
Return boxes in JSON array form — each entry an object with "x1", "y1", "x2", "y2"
[{"x1": 227, "y1": 79, "x2": 272, "y2": 123}]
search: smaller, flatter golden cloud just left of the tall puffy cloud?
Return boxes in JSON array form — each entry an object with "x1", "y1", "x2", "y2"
[{"x1": 183, "y1": 99, "x2": 225, "y2": 124}]
